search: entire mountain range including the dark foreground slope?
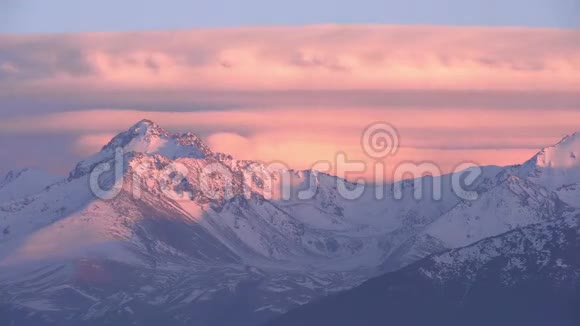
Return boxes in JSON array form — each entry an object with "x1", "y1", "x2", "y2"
[{"x1": 0, "y1": 120, "x2": 580, "y2": 326}]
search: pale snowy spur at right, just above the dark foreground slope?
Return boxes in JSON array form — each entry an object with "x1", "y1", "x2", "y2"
[{"x1": 387, "y1": 172, "x2": 574, "y2": 270}]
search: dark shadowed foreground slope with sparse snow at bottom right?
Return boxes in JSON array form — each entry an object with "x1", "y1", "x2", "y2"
[{"x1": 267, "y1": 215, "x2": 580, "y2": 326}]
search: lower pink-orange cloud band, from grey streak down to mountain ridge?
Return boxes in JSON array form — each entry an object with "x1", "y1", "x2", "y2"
[{"x1": 10, "y1": 108, "x2": 580, "y2": 181}]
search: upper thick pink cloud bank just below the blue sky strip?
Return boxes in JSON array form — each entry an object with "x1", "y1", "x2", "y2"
[{"x1": 0, "y1": 26, "x2": 580, "y2": 90}]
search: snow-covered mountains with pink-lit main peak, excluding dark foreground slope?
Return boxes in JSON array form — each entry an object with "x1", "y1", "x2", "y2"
[{"x1": 0, "y1": 120, "x2": 577, "y2": 325}]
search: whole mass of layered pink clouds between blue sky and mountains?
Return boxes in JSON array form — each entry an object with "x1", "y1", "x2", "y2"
[{"x1": 0, "y1": 26, "x2": 580, "y2": 178}]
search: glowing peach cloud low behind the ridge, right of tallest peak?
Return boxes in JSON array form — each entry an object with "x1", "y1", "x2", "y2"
[{"x1": 208, "y1": 131, "x2": 538, "y2": 179}]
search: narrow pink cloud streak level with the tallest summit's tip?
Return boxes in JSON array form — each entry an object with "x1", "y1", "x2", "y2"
[{"x1": 0, "y1": 107, "x2": 580, "y2": 138}]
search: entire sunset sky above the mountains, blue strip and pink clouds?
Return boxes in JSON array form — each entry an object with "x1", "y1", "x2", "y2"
[{"x1": 0, "y1": 0, "x2": 580, "y2": 178}]
